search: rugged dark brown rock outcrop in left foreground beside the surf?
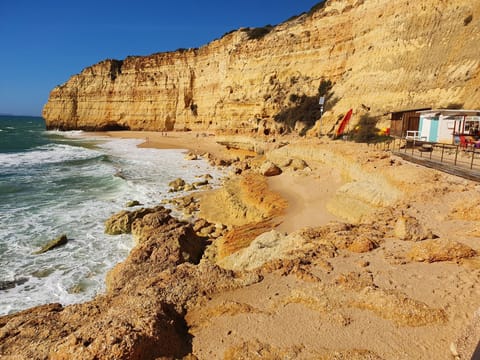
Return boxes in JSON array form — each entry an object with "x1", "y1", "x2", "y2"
[{"x1": 0, "y1": 208, "x2": 248, "y2": 359}]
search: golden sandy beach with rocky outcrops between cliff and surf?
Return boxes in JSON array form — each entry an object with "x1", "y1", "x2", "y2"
[{"x1": 0, "y1": 132, "x2": 480, "y2": 359}]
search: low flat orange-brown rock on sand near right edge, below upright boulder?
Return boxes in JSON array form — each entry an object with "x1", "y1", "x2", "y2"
[{"x1": 408, "y1": 240, "x2": 477, "y2": 263}]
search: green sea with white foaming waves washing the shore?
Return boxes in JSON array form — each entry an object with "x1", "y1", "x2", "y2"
[{"x1": 0, "y1": 116, "x2": 222, "y2": 315}]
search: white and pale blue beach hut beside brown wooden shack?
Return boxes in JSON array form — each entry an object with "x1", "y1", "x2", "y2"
[{"x1": 415, "y1": 109, "x2": 480, "y2": 144}]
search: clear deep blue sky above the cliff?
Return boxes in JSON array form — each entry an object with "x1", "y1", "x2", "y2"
[{"x1": 0, "y1": 0, "x2": 320, "y2": 115}]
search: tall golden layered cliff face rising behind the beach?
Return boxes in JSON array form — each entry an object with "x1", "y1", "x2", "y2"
[{"x1": 43, "y1": 0, "x2": 480, "y2": 132}]
